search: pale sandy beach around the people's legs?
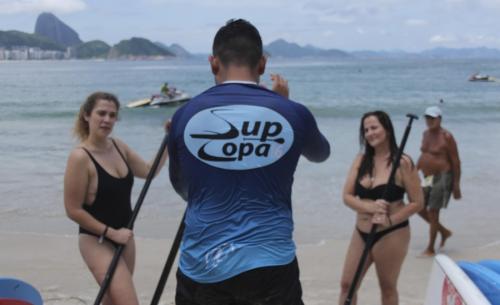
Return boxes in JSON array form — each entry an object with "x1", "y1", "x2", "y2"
[{"x1": 0, "y1": 228, "x2": 500, "y2": 305}]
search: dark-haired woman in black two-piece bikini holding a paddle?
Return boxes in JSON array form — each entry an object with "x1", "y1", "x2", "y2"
[{"x1": 339, "y1": 111, "x2": 423, "y2": 305}]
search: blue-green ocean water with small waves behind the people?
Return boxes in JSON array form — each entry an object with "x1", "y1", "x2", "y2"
[{"x1": 0, "y1": 59, "x2": 500, "y2": 251}]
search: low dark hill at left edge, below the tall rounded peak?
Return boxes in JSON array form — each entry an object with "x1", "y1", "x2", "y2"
[{"x1": 0, "y1": 31, "x2": 65, "y2": 51}]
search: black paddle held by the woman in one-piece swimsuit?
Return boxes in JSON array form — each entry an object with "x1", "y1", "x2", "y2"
[{"x1": 94, "y1": 134, "x2": 168, "y2": 305}]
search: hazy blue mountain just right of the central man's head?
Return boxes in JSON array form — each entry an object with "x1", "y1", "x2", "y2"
[{"x1": 264, "y1": 39, "x2": 351, "y2": 59}]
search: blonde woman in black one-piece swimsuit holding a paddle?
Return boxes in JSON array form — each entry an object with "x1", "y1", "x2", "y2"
[{"x1": 64, "y1": 92, "x2": 167, "y2": 305}]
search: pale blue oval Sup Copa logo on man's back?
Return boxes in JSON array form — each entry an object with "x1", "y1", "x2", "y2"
[{"x1": 184, "y1": 105, "x2": 293, "y2": 170}]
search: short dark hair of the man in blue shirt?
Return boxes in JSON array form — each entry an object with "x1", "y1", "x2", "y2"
[{"x1": 212, "y1": 19, "x2": 263, "y2": 68}]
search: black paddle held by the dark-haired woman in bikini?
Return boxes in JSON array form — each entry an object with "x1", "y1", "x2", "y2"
[{"x1": 344, "y1": 114, "x2": 418, "y2": 305}]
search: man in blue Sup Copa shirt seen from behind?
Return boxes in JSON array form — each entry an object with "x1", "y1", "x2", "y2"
[{"x1": 168, "y1": 19, "x2": 330, "y2": 305}]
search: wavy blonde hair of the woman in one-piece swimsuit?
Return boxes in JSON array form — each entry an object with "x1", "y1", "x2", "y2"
[{"x1": 73, "y1": 91, "x2": 120, "y2": 141}]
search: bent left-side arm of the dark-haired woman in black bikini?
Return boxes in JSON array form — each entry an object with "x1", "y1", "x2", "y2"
[{"x1": 343, "y1": 155, "x2": 387, "y2": 214}]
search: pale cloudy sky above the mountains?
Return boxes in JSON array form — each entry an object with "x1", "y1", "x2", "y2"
[{"x1": 0, "y1": 0, "x2": 500, "y2": 53}]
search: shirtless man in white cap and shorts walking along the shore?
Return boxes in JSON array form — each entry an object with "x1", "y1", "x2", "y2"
[{"x1": 417, "y1": 106, "x2": 462, "y2": 256}]
